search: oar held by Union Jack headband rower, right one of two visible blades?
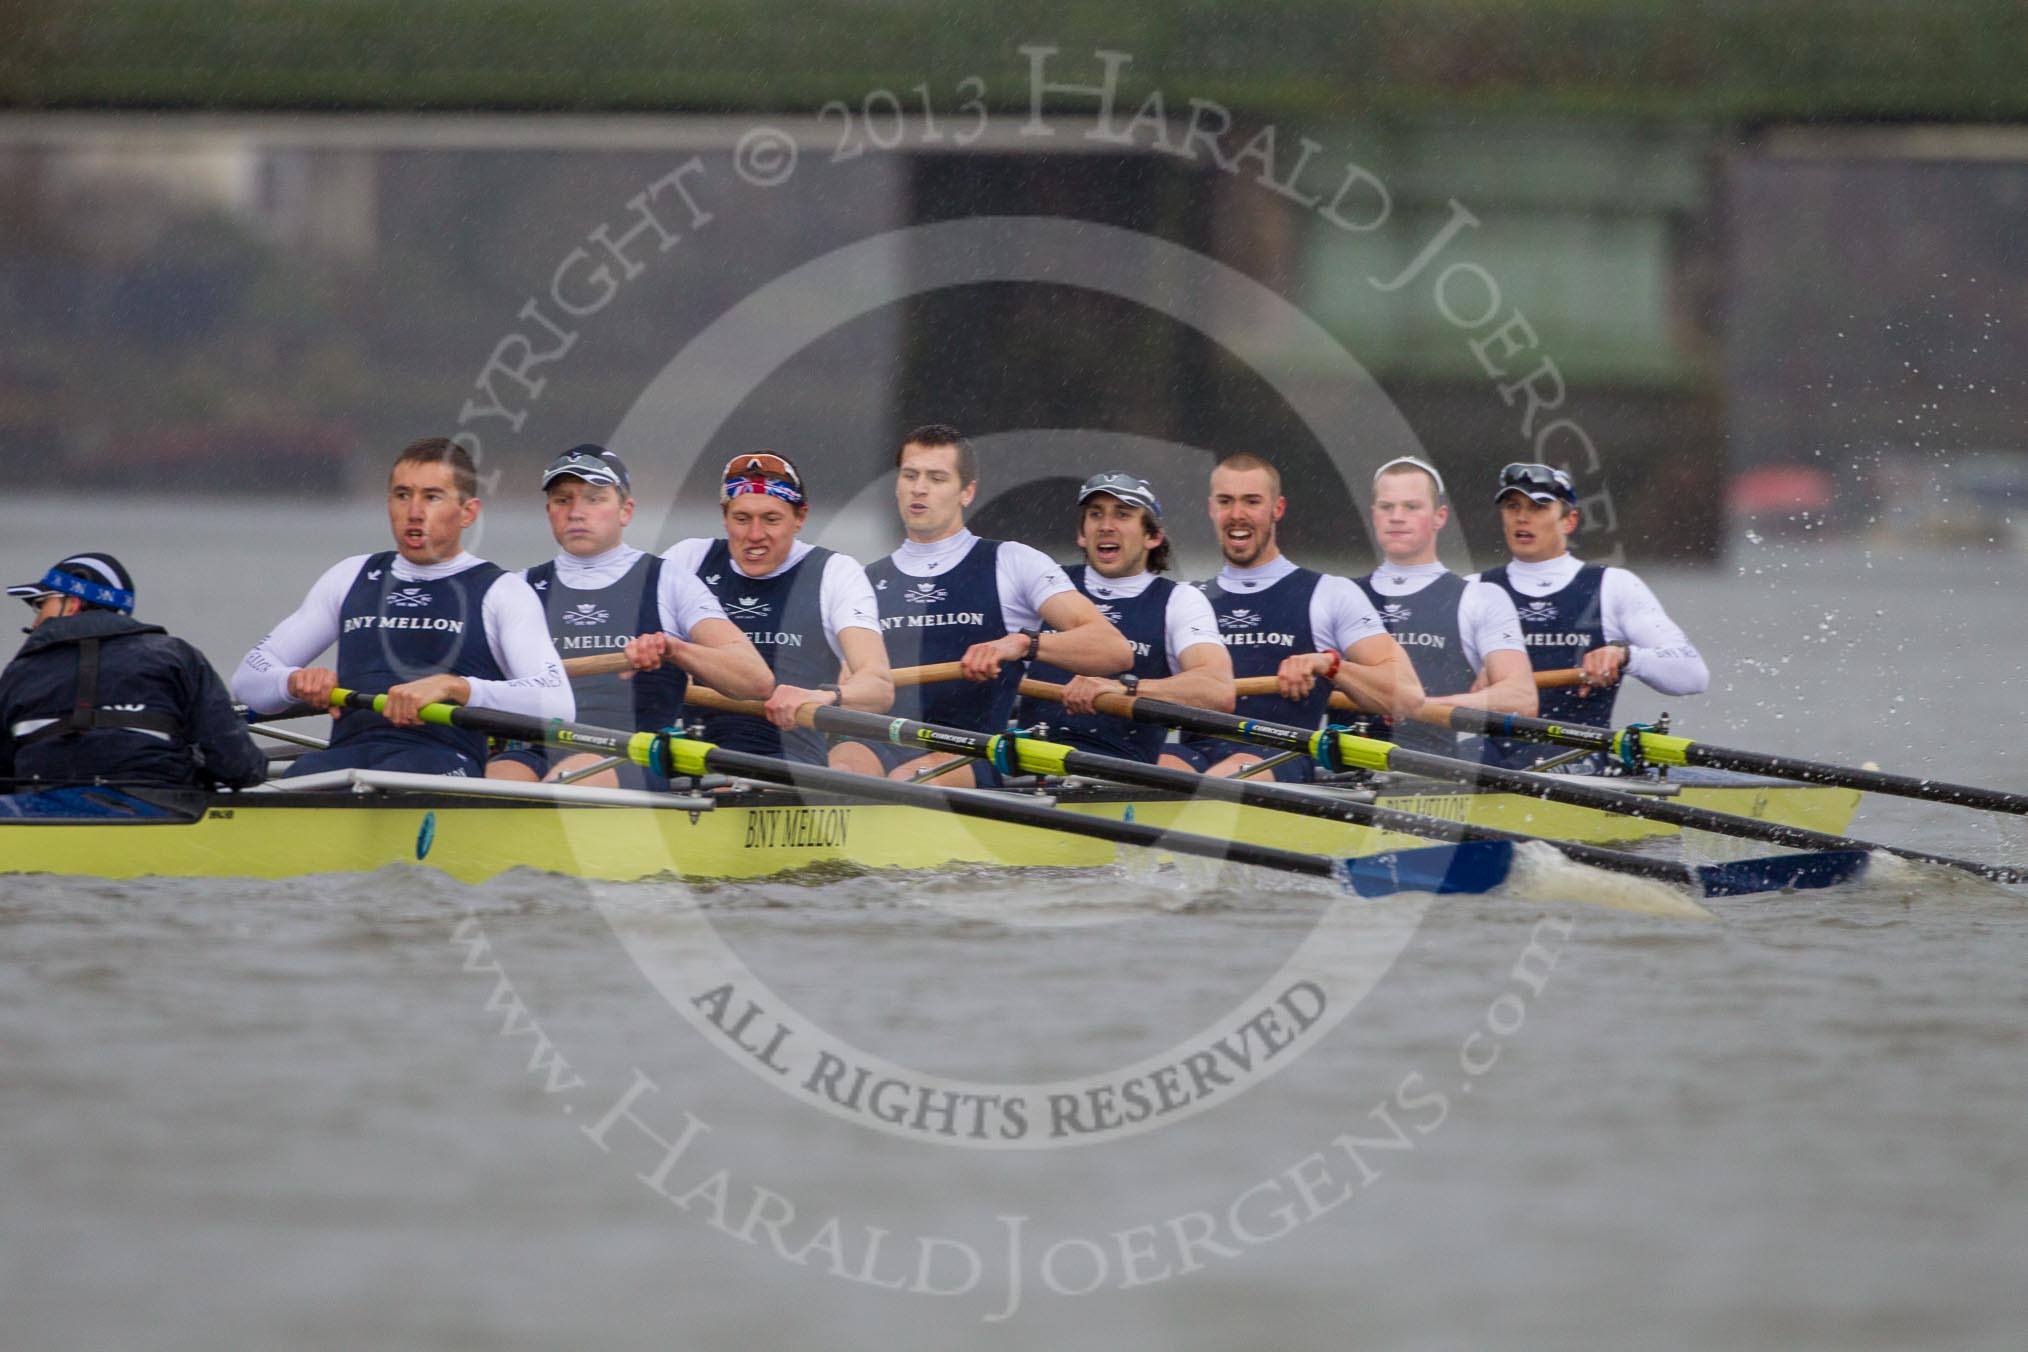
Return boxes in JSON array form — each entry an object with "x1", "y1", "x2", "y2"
[{"x1": 677, "y1": 681, "x2": 1866, "y2": 896}]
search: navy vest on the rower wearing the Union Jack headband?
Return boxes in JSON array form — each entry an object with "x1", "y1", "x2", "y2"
[{"x1": 698, "y1": 539, "x2": 840, "y2": 764}]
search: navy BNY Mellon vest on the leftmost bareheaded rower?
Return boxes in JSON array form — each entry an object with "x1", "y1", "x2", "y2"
[{"x1": 331, "y1": 549, "x2": 507, "y2": 764}]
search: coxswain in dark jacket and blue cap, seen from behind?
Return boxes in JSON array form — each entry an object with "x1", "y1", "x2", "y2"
[{"x1": 0, "y1": 553, "x2": 268, "y2": 793}]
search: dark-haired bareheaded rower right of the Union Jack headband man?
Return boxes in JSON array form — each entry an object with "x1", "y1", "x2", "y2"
[{"x1": 831, "y1": 424, "x2": 1134, "y2": 786}]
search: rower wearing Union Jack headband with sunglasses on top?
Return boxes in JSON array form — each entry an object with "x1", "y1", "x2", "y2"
[{"x1": 629, "y1": 450, "x2": 894, "y2": 764}]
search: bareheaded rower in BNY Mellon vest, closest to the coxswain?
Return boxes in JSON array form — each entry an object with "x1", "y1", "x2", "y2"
[{"x1": 233, "y1": 436, "x2": 576, "y2": 774}]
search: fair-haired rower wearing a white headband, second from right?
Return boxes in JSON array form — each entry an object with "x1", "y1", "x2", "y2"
[{"x1": 1355, "y1": 456, "x2": 1535, "y2": 756}]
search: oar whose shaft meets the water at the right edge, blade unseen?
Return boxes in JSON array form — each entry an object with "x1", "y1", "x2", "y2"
[{"x1": 1095, "y1": 681, "x2": 2028, "y2": 882}]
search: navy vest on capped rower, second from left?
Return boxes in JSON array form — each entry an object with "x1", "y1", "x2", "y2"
[{"x1": 527, "y1": 553, "x2": 690, "y2": 732}]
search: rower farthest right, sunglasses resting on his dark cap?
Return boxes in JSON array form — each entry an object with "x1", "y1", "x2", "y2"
[{"x1": 1474, "y1": 464, "x2": 1712, "y2": 768}]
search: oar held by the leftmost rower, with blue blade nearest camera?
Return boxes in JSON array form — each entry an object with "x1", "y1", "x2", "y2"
[{"x1": 331, "y1": 689, "x2": 1513, "y2": 896}]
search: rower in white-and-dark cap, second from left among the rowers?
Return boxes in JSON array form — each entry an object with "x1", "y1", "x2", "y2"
[{"x1": 487, "y1": 444, "x2": 775, "y2": 788}]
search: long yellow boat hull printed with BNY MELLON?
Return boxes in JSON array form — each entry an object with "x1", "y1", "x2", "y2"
[{"x1": 0, "y1": 780, "x2": 1860, "y2": 882}]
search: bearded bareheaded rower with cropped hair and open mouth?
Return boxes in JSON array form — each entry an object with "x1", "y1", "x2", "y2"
[{"x1": 1176, "y1": 452, "x2": 1422, "y2": 780}]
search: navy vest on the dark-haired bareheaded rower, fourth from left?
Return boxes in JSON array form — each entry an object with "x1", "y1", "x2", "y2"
[{"x1": 866, "y1": 539, "x2": 1028, "y2": 732}]
